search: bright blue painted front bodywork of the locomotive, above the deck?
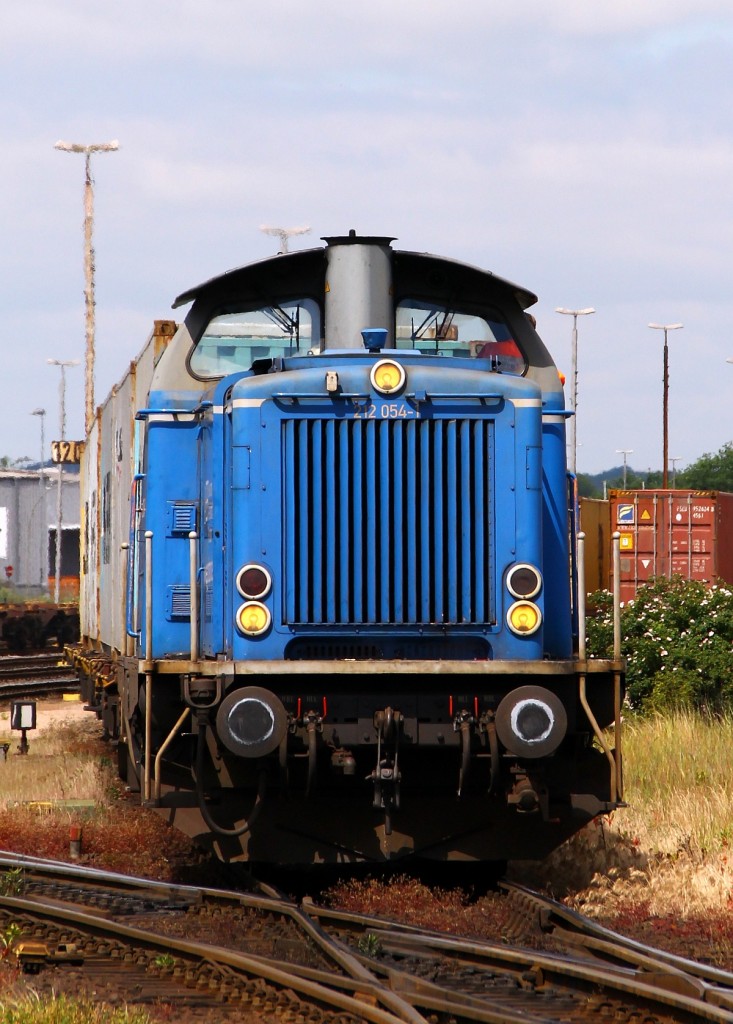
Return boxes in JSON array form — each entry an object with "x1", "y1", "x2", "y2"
[{"x1": 133, "y1": 353, "x2": 571, "y2": 659}]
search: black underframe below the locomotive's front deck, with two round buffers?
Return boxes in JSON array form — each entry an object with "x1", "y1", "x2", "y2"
[{"x1": 75, "y1": 663, "x2": 618, "y2": 865}]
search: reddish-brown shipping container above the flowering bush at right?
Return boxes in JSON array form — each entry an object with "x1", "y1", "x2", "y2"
[{"x1": 608, "y1": 489, "x2": 733, "y2": 602}]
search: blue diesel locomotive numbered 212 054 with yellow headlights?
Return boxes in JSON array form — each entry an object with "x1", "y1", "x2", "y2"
[{"x1": 70, "y1": 231, "x2": 623, "y2": 864}]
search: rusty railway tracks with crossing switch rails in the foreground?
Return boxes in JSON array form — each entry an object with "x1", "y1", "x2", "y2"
[{"x1": 0, "y1": 854, "x2": 733, "y2": 1024}]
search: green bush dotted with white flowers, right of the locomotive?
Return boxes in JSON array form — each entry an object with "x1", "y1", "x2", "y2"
[{"x1": 587, "y1": 575, "x2": 733, "y2": 714}]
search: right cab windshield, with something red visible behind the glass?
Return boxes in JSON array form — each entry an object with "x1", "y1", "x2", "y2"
[{"x1": 395, "y1": 299, "x2": 526, "y2": 374}]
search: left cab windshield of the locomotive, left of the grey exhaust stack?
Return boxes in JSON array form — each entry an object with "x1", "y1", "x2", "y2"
[{"x1": 188, "y1": 299, "x2": 320, "y2": 379}]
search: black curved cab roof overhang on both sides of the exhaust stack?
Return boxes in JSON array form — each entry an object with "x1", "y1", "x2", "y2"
[{"x1": 172, "y1": 236, "x2": 537, "y2": 309}]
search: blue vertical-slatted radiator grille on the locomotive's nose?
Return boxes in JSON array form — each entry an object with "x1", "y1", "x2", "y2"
[{"x1": 283, "y1": 418, "x2": 493, "y2": 626}]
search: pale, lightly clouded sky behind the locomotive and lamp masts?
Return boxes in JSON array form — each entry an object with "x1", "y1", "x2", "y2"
[{"x1": 0, "y1": 0, "x2": 733, "y2": 473}]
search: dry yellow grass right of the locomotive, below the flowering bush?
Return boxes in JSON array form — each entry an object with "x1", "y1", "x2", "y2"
[{"x1": 513, "y1": 713, "x2": 733, "y2": 950}]
